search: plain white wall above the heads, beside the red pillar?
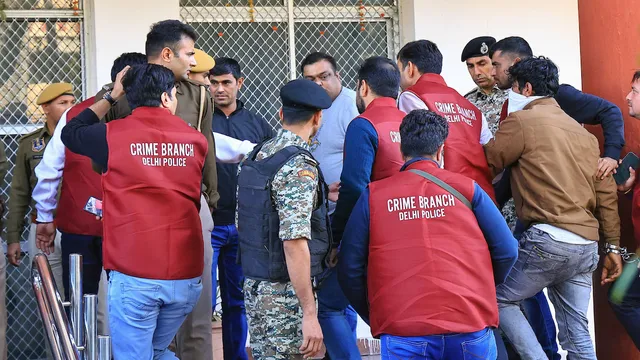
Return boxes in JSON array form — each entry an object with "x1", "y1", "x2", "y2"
[{"x1": 408, "y1": 0, "x2": 582, "y2": 94}]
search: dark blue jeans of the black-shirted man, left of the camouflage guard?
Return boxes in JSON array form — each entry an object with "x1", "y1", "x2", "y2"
[{"x1": 211, "y1": 225, "x2": 248, "y2": 360}]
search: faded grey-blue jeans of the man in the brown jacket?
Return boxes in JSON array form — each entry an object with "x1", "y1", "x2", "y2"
[{"x1": 496, "y1": 228, "x2": 599, "y2": 360}]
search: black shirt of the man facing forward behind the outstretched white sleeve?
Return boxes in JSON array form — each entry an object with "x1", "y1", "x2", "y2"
[{"x1": 212, "y1": 100, "x2": 275, "y2": 226}]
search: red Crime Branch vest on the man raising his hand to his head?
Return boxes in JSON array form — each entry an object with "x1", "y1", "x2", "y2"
[{"x1": 102, "y1": 107, "x2": 207, "y2": 280}]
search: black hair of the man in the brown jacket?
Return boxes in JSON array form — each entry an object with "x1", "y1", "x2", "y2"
[{"x1": 509, "y1": 56, "x2": 560, "y2": 96}]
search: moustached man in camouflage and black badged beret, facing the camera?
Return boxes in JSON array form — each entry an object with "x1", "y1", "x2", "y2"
[{"x1": 460, "y1": 36, "x2": 516, "y2": 230}]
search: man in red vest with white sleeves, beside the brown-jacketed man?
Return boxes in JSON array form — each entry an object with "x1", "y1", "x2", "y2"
[{"x1": 398, "y1": 40, "x2": 494, "y2": 199}]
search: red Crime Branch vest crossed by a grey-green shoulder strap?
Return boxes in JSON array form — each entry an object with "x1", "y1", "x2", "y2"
[{"x1": 367, "y1": 160, "x2": 498, "y2": 337}]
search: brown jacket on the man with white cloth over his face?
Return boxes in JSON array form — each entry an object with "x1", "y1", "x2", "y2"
[{"x1": 484, "y1": 98, "x2": 620, "y2": 244}]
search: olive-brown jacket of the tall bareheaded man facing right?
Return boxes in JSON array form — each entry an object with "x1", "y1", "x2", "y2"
[{"x1": 96, "y1": 80, "x2": 220, "y2": 208}]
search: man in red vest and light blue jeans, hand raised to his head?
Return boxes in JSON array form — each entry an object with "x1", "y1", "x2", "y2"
[{"x1": 61, "y1": 64, "x2": 208, "y2": 359}]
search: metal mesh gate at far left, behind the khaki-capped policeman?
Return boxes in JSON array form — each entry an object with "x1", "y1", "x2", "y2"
[{"x1": 0, "y1": 0, "x2": 85, "y2": 360}]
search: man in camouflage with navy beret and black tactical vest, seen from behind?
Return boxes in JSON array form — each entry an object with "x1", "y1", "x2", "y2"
[{"x1": 236, "y1": 79, "x2": 331, "y2": 360}]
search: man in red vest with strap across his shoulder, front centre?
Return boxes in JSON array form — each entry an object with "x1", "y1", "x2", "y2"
[{"x1": 338, "y1": 110, "x2": 518, "y2": 359}]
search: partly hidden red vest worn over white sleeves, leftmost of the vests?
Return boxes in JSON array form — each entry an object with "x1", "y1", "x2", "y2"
[{"x1": 56, "y1": 97, "x2": 102, "y2": 236}]
